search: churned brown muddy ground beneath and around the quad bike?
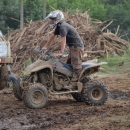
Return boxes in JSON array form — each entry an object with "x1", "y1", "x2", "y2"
[{"x1": 0, "y1": 72, "x2": 130, "y2": 130}]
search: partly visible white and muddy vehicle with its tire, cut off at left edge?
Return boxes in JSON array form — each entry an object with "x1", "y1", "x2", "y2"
[{"x1": 0, "y1": 32, "x2": 13, "y2": 90}]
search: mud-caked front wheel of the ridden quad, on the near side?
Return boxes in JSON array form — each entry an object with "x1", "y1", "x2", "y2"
[{"x1": 23, "y1": 83, "x2": 48, "y2": 109}]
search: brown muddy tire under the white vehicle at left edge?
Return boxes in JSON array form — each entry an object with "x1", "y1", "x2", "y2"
[{"x1": 0, "y1": 65, "x2": 8, "y2": 90}]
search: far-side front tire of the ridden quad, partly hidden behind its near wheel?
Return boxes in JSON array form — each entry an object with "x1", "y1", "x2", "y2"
[{"x1": 13, "y1": 79, "x2": 23, "y2": 101}]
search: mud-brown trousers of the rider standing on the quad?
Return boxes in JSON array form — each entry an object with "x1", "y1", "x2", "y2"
[{"x1": 67, "y1": 46, "x2": 84, "y2": 77}]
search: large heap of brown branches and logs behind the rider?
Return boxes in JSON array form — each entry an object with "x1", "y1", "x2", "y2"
[{"x1": 8, "y1": 12, "x2": 129, "y2": 73}]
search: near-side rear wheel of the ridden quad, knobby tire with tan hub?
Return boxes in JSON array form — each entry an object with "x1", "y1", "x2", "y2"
[{"x1": 82, "y1": 82, "x2": 108, "y2": 106}]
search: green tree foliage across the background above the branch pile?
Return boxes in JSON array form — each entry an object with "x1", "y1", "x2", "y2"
[{"x1": 0, "y1": 0, "x2": 130, "y2": 39}]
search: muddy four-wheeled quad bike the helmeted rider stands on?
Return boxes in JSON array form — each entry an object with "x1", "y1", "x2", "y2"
[{"x1": 14, "y1": 52, "x2": 108, "y2": 109}]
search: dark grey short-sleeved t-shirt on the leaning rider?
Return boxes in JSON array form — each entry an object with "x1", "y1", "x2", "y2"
[{"x1": 54, "y1": 22, "x2": 84, "y2": 48}]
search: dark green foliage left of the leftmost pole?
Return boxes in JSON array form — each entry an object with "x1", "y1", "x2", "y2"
[{"x1": 0, "y1": 0, "x2": 19, "y2": 33}]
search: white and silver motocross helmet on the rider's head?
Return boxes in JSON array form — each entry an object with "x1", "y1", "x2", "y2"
[{"x1": 45, "y1": 10, "x2": 64, "y2": 28}]
